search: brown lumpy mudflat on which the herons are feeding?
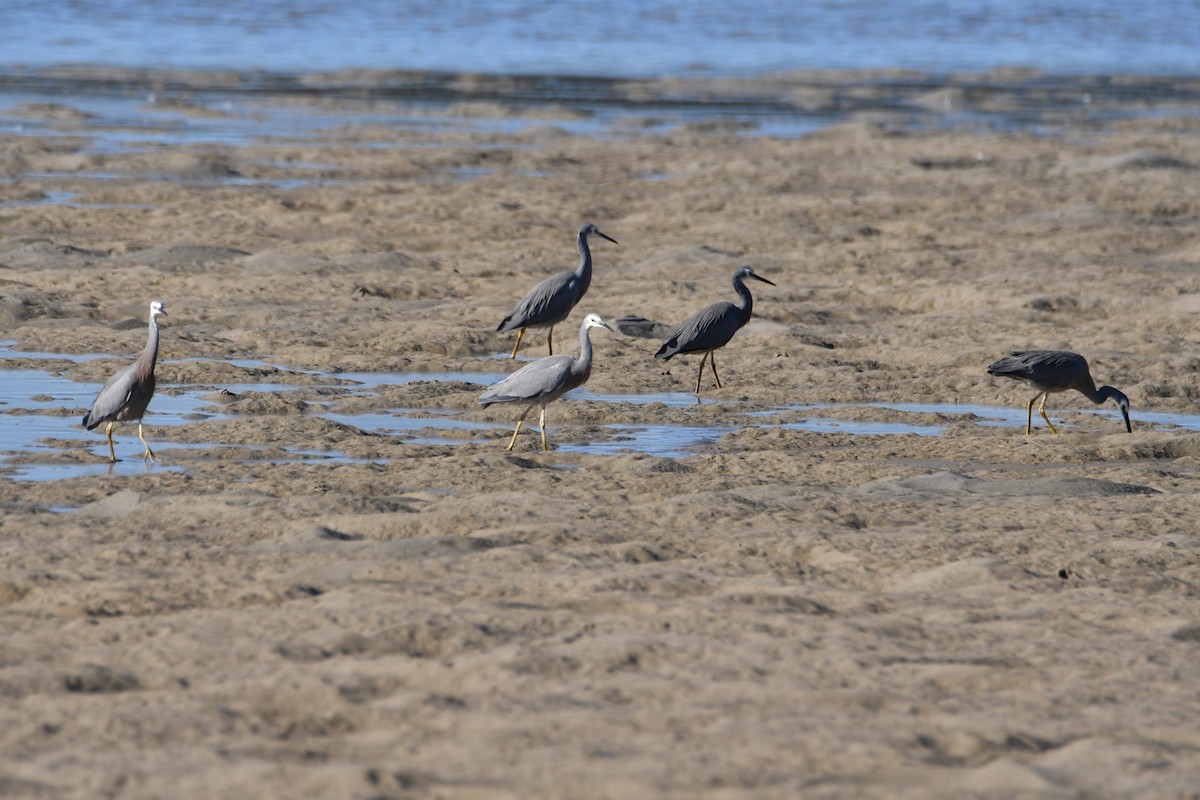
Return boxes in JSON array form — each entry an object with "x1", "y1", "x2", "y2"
[{"x1": 0, "y1": 82, "x2": 1200, "y2": 799}]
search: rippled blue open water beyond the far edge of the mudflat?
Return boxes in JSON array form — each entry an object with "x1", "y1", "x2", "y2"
[{"x1": 0, "y1": 0, "x2": 1200, "y2": 77}]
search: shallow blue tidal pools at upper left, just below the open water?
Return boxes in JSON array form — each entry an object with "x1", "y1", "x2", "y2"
[{"x1": 0, "y1": 80, "x2": 825, "y2": 167}]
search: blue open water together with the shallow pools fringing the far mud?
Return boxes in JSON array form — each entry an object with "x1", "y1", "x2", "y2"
[{"x1": 7, "y1": 0, "x2": 1200, "y2": 190}]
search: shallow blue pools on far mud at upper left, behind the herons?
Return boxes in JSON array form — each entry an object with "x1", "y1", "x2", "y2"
[{"x1": 0, "y1": 86, "x2": 758, "y2": 183}]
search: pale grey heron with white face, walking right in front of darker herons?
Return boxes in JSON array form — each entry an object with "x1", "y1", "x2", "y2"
[{"x1": 479, "y1": 314, "x2": 612, "y2": 452}]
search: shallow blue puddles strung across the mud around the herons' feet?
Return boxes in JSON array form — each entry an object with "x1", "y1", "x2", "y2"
[{"x1": 0, "y1": 342, "x2": 1200, "y2": 481}]
